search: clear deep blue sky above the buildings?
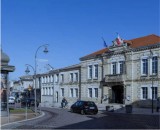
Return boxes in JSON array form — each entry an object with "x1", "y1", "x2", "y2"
[{"x1": 1, "y1": 0, "x2": 160, "y2": 80}]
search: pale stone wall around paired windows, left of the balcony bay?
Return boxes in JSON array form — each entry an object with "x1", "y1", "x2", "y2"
[{"x1": 81, "y1": 59, "x2": 102, "y2": 103}]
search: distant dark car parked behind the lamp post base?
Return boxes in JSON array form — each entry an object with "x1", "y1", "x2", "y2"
[{"x1": 21, "y1": 98, "x2": 39, "y2": 107}]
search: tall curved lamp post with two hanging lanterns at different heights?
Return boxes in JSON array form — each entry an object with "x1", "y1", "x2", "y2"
[{"x1": 25, "y1": 44, "x2": 48, "y2": 113}]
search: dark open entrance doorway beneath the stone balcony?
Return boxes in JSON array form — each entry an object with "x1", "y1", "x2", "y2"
[{"x1": 112, "y1": 85, "x2": 124, "y2": 104}]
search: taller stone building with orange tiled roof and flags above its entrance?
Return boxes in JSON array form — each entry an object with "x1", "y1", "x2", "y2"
[{"x1": 80, "y1": 35, "x2": 160, "y2": 107}]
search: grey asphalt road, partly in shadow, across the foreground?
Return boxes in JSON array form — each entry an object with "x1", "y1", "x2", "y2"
[{"x1": 2, "y1": 108, "x2": 160, "y2": 129}]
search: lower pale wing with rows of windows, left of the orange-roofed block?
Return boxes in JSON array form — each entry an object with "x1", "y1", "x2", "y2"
[{"x1": 41, "y1": 64, "x2": 81, "y2": 106}]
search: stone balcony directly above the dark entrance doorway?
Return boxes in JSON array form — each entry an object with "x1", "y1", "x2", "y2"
[{"x1": 105, "y1": 74, "x2": 126, "y2": 83}]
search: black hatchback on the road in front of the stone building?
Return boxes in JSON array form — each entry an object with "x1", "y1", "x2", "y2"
[{"x1": 70, "y1": 101, "x2": 98, "y2": 115}]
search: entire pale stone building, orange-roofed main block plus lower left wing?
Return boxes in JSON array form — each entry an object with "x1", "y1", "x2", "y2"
[{"x1": 19, "y1": 34, "x2": 160, "y2": 107}]
